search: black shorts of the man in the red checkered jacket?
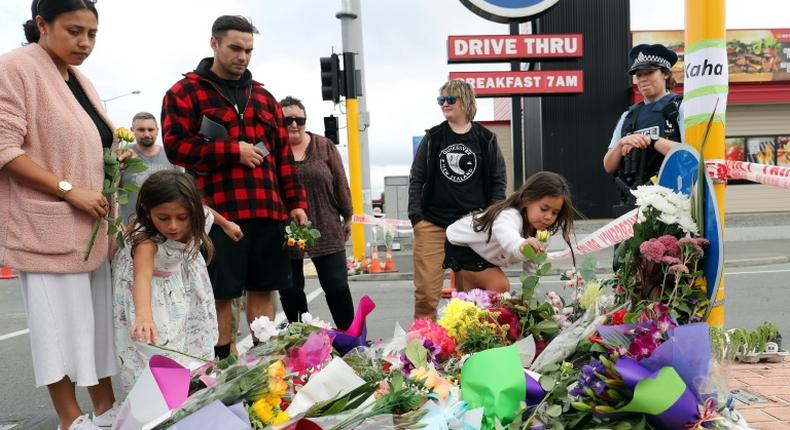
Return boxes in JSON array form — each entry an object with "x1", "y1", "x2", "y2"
[{"x1": 208, "y1": 219, "x2": 291, "y2": 300}]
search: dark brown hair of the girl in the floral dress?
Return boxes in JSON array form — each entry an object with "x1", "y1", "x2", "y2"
[{"x1": 124, "y1": 170, "x2": 214, "y2": 260}]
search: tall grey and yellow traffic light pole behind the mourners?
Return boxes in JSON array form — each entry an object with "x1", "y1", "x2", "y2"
[{"x1": 335, "y1": 0, "x2": 375, "y2": 259}]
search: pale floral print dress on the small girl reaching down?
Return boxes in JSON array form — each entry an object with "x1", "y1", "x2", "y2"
[{"x1": 112, "y1": 240, "x2": 218, "y2": 392}]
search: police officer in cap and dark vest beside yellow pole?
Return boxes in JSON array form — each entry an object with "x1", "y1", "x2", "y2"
[{"x1": 603, "y1": 44, "x2": 683, "y2": 216}]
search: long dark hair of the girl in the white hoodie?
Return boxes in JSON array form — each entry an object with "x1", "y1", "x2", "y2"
[{"x1": 472, "y1": 172, "x2": 579, "y2": 266}]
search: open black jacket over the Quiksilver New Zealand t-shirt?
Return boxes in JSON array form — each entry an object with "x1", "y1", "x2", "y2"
[{"x1": 409, "y1": 121, "x2": 507, "y2": 225}]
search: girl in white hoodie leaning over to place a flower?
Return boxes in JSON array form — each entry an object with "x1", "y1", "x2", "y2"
[{"x1": 444, "y1": 172, "x2": 577, "y2": 292}]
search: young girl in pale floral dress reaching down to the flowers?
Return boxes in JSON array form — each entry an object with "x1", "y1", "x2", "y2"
[{"x1": 112, "y1": 171, "x2": 242, "y2": 392}]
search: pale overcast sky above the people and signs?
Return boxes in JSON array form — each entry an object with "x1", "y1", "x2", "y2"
[{"x1": 0, "y1": 0, "x2": 790, "y2": 196}]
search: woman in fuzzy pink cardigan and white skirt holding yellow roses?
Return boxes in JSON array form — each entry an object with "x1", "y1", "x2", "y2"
[{"x1": 0, "y1": 0, "x2": 118, "y2": 429}]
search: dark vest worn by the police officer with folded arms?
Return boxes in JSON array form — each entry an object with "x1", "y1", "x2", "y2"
[{"x1": 615, "y1": 94, "x2": 683, "y2": 189}]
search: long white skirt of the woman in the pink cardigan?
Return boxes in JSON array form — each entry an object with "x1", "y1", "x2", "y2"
[{"x1": 19, "y1": 263, "x2": 118, "y2": 387}]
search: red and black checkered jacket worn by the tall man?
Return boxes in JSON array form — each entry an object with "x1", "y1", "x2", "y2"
[{"x1": 162, "y1": 65, "x2": 307, "y2": 221}]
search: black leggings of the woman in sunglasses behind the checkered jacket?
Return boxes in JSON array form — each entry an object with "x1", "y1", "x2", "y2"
[{"x1": 280, "y1": 251, "x2": 354, "y2": 330}]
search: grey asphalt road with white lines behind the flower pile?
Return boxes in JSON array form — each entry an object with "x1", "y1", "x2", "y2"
[{"x1": 0, "y1": 263, "x2": 790, "y2": 430}]
